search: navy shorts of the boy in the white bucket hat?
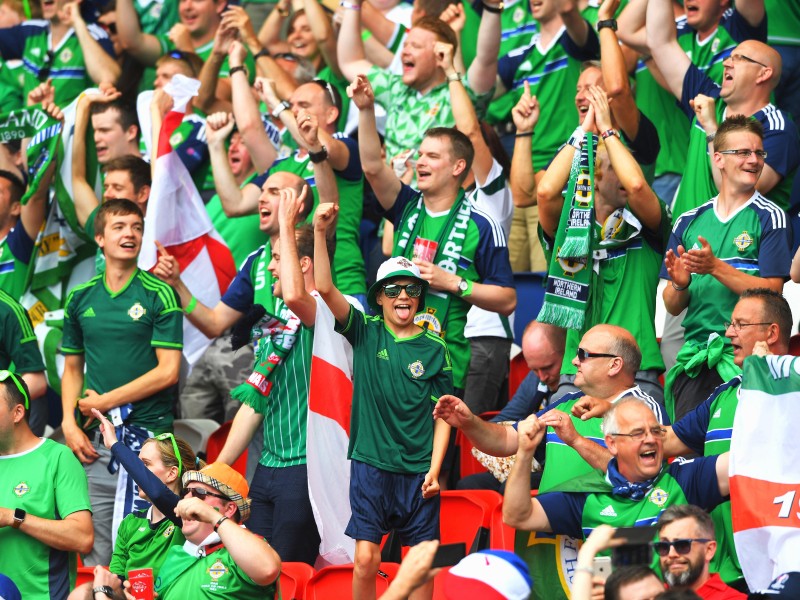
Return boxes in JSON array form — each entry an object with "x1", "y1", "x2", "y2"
[{"x1": 345, "y1": 460, "x2": 441, "y2": 546}]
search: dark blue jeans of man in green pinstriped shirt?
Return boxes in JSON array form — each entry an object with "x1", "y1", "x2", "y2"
[{"x1": 247, "y1": 464, "x2": 320, "y2": 566}]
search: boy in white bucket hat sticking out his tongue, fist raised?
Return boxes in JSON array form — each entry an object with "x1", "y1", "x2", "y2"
[{"x1": 314, "y1": 203, "x2": 453, "y2": 600}]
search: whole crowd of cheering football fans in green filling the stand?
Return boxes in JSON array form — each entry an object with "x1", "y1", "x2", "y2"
[{"x1": 0, "y1": 0, "x2": 800, "y2": 600}]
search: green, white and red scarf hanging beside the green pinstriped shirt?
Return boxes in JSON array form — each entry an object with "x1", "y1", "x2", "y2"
[{"x1": 231, "y1": 301, "x2": 302, "y2": 414}]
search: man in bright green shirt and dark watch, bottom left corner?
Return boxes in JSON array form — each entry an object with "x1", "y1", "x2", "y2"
[{"x1": 0, "y1": 371, "x2": 94, "y2": 600}]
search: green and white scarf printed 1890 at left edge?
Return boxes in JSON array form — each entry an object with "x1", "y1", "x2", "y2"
[{"x1": 0, "y1": 104, "x2": 61, "y2": 204}]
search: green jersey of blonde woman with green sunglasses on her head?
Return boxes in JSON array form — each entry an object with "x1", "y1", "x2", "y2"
[{"x1": 108, "y1": 511, "x2": 186, "y2": 579}]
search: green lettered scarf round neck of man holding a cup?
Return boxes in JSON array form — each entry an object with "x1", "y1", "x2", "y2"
[{"x1": 393, "y1": 190, "x2": 471, "y2": 337}]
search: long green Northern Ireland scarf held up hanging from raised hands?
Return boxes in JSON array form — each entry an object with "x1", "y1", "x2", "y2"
[{"x1": 537, "y1": 133, "x2": 597, "y2": 329}]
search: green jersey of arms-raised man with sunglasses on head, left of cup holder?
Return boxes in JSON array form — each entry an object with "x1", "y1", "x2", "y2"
[{"x1": 269, "y1": 143, "x2": 367, "y2": 295}]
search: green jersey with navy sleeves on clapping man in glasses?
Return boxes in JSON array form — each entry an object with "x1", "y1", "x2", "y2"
[{"x1": 662, "y1": 192, "x2": 791, "y2": 345}]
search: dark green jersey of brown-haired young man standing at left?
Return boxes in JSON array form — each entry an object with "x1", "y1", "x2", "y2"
[{"x1": 61, "y1": 269, "x2": 183, "y2": 433}]
